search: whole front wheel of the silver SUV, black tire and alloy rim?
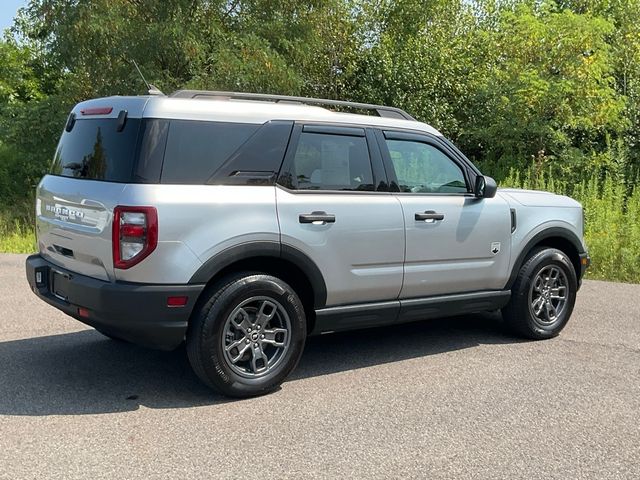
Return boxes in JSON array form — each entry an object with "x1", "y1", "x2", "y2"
[{"x1": 502, "y1": 247, "x2": 578, "y2": 340}]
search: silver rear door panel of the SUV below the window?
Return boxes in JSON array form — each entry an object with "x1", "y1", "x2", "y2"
[{"x1": 276, "y1": 187, "x2": 405, "y2": 305}]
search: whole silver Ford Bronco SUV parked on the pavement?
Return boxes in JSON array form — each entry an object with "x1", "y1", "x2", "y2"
[{"x1": 26, "y1": 90, "x2": 589, "y2": 397}]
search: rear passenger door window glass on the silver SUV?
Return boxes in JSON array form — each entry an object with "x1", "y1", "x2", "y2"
[{"x1": 291, "y1": 132, "x2": 374, "y2": 191}]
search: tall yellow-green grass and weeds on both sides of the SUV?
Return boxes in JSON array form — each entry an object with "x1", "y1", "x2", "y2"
[{"x1": 0, "y1": 168, "x2": 640, "y2": 283}]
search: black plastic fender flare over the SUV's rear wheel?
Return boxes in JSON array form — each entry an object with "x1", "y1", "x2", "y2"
[{"x1": 189, "y1": 241, "x2": 327, "y2": 309}]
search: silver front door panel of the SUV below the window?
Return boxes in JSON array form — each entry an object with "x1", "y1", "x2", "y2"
[{"x1": 398, "y1": 194, "x2": 511, "y2": 298}]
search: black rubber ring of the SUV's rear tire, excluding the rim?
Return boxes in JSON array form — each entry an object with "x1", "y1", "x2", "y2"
[{"x1": 199, "y1": 275, "x2": 306, "y2": 396}]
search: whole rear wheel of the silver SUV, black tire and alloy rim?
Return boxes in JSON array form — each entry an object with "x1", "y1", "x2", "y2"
[{"x1": 187, "y1": 272, "x2": 307, "y2": 397}]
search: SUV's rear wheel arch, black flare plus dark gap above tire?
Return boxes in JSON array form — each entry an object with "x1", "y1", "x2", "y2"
[{"x1": 189, "y1": 242, "x2": 327, "y2": 331}]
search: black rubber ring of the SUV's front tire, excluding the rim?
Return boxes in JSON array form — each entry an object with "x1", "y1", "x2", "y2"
[{"x1": 517, "y1": 248, "x2": 578, "y2": 338}]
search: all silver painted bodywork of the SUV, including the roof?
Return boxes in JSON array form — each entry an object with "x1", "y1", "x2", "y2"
[{"x1": 36, "y1": 97, "x2": 586, "y2": 307}]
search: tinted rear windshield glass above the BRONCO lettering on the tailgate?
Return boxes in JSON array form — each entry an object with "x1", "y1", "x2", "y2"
[{"x1": 51, "y1": 118, "x2": 140, "y2": 182}]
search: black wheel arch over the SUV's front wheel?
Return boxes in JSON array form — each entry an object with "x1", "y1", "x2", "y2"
[{"x1": 505, "y1": 227, "x2": 584, "y2": 289}]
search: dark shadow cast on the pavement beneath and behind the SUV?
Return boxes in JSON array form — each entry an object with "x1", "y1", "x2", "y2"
[{"x1": 0, "y1": 314, "x2": 518, "y2": 416}]
